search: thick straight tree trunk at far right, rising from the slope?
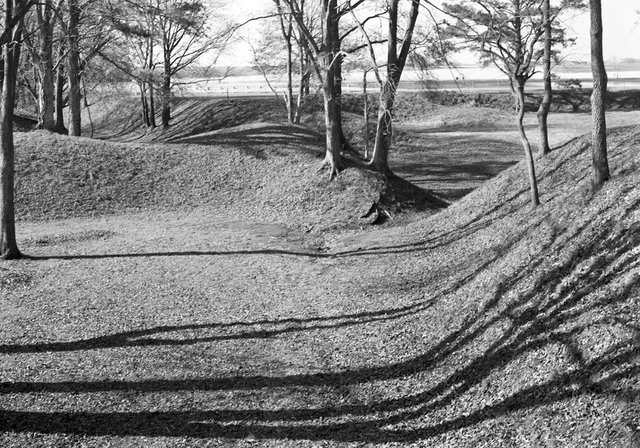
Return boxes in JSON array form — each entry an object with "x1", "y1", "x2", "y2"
[{"x1": 589, "y1": 0, "x2": 610, "y2": 185}]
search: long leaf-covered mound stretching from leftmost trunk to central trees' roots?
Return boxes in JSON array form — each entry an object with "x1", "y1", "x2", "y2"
[{"x1": 16, "y1": 128, "x2": 444, "y2": 230}]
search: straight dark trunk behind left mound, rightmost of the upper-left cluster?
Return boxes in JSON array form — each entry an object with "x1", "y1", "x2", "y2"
[{"x1": 67, "y1": 0, "x2": 82, "y2": 137}]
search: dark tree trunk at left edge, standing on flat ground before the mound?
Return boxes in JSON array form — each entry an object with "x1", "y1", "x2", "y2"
[{"x1": 0, "y1": 0, "x2": 22, "y2": 260}]
